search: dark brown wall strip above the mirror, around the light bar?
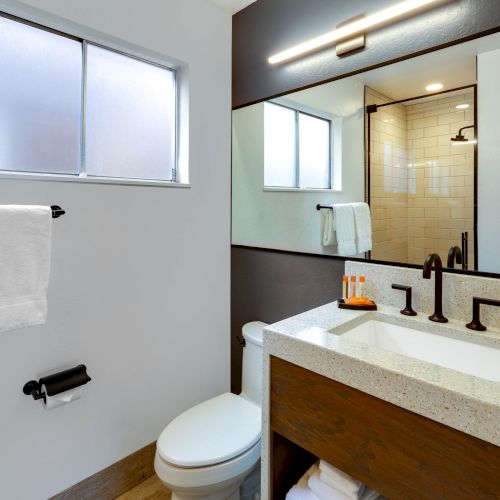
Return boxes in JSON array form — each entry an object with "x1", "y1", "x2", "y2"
[{"x1": 233, "y1": 0, "x2": 500, "y2": 107}]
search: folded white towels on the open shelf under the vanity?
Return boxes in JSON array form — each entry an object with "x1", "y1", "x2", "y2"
[{"x1": 286, "y1": 460, "x2": 382, "y2": 500}]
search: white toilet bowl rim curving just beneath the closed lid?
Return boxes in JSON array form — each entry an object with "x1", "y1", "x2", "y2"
[{"x1": 154, "y1": 439, "x2": 260, "y2": 489}]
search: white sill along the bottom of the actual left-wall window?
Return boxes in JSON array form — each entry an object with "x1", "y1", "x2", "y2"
[{"x1": 0, "y1": 171, "x2": 191, "y2": 188}]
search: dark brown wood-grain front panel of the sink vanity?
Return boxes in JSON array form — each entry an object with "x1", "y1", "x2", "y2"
[{"x1": 271, "y1": 357, "x2": 500, "y2": 500}]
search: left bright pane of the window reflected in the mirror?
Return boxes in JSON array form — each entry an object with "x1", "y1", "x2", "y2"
[{"x1": 264, "y1": 102, "x2": 297, "y2": 187}]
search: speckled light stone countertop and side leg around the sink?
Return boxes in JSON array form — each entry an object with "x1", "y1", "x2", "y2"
[{"x1": 262, "y1": 302, "x2": 500, "y2": 499}]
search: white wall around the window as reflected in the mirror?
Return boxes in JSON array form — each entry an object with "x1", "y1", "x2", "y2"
[{"x1": 232, "y1": 78, "x2": 365, "y2": 255}]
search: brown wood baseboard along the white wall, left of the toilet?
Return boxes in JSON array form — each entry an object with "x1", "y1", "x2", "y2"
[{"x1": 49, "y1": 442, "x2": 156, "y2": 500}]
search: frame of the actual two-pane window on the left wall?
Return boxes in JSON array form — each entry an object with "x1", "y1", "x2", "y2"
[{"x1": 0, "y1": 10, "x2": 184, "y2": 187}]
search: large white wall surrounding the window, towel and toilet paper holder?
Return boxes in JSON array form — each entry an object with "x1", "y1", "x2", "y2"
[{"x1": 0, "y1": 0, "x2": 231, "y2": 500}]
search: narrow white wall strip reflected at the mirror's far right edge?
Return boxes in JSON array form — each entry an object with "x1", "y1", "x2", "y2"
[{"x1": 477, "y1": 50, "x2": 500, "y2": 273}]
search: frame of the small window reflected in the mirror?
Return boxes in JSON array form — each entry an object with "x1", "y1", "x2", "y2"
[{"x1": 263, "y1": 98, "x2": 337, "y2": 193}]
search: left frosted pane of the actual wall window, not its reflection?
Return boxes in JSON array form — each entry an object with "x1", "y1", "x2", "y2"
[{"x1": 0, "y1": 17, "x2": 82, "y2": 174}]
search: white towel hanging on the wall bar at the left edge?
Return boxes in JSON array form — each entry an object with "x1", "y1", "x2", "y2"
[{"x1": 0, "y1": 205, "x2": 52, "y2": 332}]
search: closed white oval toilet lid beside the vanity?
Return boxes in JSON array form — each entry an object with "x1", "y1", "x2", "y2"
[{"x1": 156, "y1": 392, "x2": 261, "y2": 467}]
